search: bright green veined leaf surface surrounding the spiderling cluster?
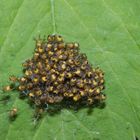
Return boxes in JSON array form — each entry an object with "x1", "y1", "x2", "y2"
[{"x1": 0, "y1": 0, "x2": 140, "y2": 140}]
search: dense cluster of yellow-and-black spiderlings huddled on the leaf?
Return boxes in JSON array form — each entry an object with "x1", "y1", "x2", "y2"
[{"x1": 5, "y1": 35, "x2": 105, "y2": 117}]
